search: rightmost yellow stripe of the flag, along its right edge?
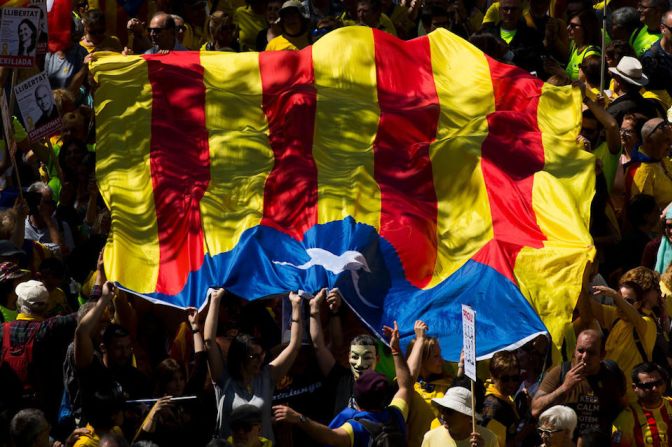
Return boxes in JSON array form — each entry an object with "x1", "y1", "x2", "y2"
[{"x1": 514, "y1": 84, "x2": 595, "y2": 356}]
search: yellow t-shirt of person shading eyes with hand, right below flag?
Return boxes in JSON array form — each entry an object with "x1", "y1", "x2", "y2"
[{"x1": 601, "y1": 304, "x2": 656, "y2": 403}]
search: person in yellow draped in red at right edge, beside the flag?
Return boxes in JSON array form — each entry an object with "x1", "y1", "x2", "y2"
[{"x1": 628, "y1": 118, "x2": 672, "y2": 209}]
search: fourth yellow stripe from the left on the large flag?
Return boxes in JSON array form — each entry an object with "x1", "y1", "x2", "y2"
[{"x1": 426, "y1": 30, "x2": 495, "y2": 288}]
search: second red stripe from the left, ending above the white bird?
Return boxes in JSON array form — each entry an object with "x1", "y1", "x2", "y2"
[{"x1": 259, "y1": 47, "x2": 317, "y2": 240}]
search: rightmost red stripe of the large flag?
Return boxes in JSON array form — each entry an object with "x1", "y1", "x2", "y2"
[{"x1": 473, "y1": 58, "x2": 546, "y2": 283}]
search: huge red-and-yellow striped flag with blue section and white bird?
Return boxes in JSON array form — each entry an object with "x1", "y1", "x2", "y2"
[{"x1": 92, "y1": 27, "x2": 595, "y2": 359}]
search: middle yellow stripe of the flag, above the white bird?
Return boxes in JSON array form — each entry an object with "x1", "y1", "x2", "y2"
[{"x1": 313, "y1": 27, "x2": 380, "y2": 229}]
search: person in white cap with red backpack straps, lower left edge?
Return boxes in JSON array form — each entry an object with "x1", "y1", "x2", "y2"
[{"x1": 0, "y1": 280, "x2": 77, "y2": 420}]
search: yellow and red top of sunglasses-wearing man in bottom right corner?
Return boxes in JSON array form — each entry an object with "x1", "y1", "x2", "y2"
[{"x1": 611, "y1": 397, "x2": 672, "y2": 447}]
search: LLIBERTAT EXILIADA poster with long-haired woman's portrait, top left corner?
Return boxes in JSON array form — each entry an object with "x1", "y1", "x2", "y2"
[{"x1": 0, "y1": 8, "x2": 40, "y2": 68}]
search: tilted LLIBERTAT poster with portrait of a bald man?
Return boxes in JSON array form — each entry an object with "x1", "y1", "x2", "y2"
[{"x1": 14, "y1": 72, "x2": 61, "y2": 141}]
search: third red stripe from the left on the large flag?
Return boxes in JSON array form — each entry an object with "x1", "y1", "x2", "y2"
[{"x1": 373, "y1": 30, "x2": 440, "y2": 288}]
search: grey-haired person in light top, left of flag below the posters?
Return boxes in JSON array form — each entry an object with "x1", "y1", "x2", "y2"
[{"x1": 24, "y1": 182, "x2": 75, "y2": 255}]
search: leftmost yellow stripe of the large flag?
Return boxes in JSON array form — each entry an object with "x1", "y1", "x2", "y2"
[{"x1": 94, "y1": 53, "x2": 159, "y2": 293}]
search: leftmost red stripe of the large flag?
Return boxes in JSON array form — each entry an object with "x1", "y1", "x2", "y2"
[{"x1": 144, "y1": 52, "x2": 210, "y2": 295}]
